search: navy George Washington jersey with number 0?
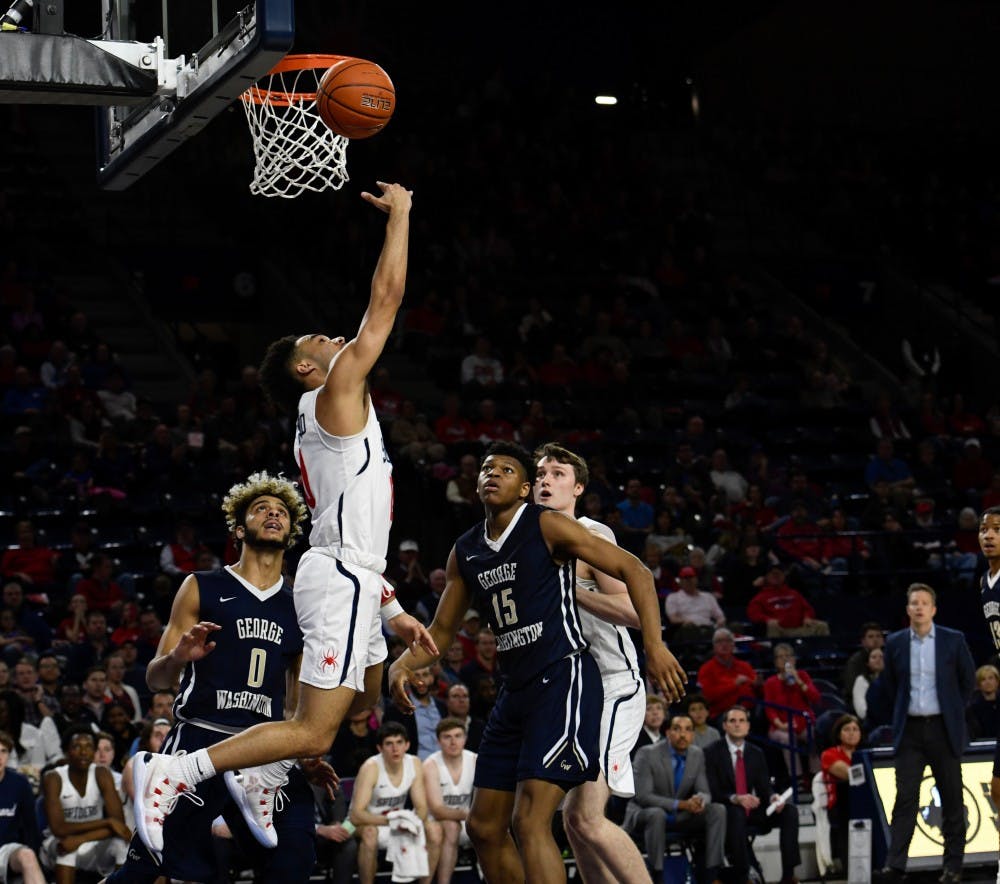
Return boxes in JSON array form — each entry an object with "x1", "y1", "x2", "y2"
[{"x1": 174, "y1": 570, "x2": 303, "y2": 733}]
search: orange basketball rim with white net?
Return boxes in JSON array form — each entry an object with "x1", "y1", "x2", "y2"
[{"x1": 241, "y1": 55, "x2": 348, "y2": 199}]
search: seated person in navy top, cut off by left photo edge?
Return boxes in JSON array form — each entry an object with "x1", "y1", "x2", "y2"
[{"x1": 0, "y1": 731, "x2": 45, "y2": 884}]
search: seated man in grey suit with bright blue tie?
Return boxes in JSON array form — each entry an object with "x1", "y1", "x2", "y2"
[{"x1": 624, "y1": 715, "x2": 726, "y2": 881}]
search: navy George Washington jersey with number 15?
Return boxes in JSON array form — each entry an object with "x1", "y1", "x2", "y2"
[{"x1": 455, "y1": 503, "x2": 587, "y2": 688}]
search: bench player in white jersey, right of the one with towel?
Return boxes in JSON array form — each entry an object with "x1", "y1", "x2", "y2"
[{"x1": 424, "y1": 717, "x2": 476, "y2": 882}]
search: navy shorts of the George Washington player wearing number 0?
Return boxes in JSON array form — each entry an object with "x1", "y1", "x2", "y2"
[{"x1": 107, "y1": 722, "x2": 316, "y2": 884}]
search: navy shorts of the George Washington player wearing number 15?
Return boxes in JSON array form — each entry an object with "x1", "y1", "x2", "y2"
[{"x1": 475, "y1": 651, "x2": 604, "y2": 792}]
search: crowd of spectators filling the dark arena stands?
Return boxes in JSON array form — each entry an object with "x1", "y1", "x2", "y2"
[{"x1": 0, "y1": 46, "x2": 1000, "y2": 868}]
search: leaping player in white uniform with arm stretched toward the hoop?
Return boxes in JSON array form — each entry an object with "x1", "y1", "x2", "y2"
[{"x1": 135, "y1": 182, "x2": 436, "y2": 853}]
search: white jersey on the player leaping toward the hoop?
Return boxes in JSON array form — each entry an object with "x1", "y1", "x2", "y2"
[{"x1": 295, "y1": 388, "x2": 392, "y2": 574}]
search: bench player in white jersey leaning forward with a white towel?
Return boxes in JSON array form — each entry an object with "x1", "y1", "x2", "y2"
[{"x1": 350, "y1": 722, "x2": 441, "y2": 884}]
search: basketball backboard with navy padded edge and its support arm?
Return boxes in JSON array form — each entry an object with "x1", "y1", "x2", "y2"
[{"x1": 0, "y1": 0, "x2": 295, "y2": 190}]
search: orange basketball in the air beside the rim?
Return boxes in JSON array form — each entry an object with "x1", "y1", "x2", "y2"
[{"x1": 316, "y1": 58, "x2": 396, "y2": 138}]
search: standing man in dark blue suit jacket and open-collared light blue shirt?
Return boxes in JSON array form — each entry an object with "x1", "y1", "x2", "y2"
[{"x1": 868, "y1": 583, "x2": 976, "y2": 884}]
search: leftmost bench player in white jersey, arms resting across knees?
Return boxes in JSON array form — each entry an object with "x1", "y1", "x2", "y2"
[{"x1": 41, "y1": 726, "x2": 132, "y2": 884}]
